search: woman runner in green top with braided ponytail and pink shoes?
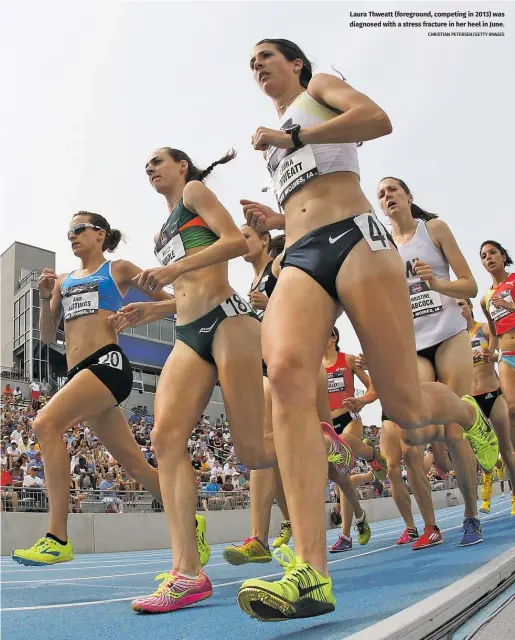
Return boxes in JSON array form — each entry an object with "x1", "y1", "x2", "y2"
[{"x1": 116, "y1": 147, "x2": 276, "y2": 613}]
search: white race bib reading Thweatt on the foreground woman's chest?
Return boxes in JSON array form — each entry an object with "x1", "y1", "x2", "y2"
[{"x1": 267, "y1": 145, "x2": 319, "y2": 205}]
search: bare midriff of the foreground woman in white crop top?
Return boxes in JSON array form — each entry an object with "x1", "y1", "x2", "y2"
[{"x1": 284, "y1": 171, "x2": 373, "y2": 246}]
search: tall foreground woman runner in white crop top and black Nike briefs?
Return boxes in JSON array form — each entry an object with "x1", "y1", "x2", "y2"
[{"x1": 238, "y1": 40, "x2": 497, "y2": 620}]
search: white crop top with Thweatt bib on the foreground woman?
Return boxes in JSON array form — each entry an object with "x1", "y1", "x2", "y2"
[{"x1": 266, "y1": 91, "x2": 359, "y2": 205}]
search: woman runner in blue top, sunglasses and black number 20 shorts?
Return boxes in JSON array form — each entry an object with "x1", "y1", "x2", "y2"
[{"x1": 12, "y1": 211, "x2": 173, "y2": 565}]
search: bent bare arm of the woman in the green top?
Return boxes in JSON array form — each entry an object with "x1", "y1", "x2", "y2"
[{"x1": 174, "y1": 180, "x2": 249, "y2": 275}]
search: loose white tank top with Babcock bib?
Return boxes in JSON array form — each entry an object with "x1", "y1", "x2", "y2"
[{"x1": 397, "y1": 220, "x2": 467, "y2": 351}]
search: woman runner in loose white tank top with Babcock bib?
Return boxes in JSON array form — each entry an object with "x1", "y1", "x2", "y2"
[{"x1": 377, "y1": 178, "x2": 494, "y2": 546}]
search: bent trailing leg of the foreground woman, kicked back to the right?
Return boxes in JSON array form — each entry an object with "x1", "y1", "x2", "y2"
[{"x1": 337, "y1": 241, "x2": 476, "y2": 436}]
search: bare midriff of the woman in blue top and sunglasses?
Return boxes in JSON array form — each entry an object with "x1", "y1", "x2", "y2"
[{"x1": 64, "y1": 309, "x2": 118, "y2": 370}]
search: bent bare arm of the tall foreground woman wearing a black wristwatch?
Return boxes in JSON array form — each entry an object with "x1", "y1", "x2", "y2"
[{"x1": 299, "y1": 73, "x2": 392, "y2": 144}]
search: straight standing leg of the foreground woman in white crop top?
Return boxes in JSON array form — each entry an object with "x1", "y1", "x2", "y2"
[{"x1": 262, "y1": 267, "x2": 336, "y2": 575}]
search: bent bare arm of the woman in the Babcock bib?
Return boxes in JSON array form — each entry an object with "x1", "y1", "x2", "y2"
[{"x1": 422, "y1": 220, "x2": 477, "y2": 299}]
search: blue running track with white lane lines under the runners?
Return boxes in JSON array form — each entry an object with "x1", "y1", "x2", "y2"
[{"x1": 0, "y1": 496, "x2": 515, "y2": 640}]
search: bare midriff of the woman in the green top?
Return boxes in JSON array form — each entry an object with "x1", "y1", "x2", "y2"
[{"x1": 173, "y1": 247, "x2": 235, "y2": 325}]
